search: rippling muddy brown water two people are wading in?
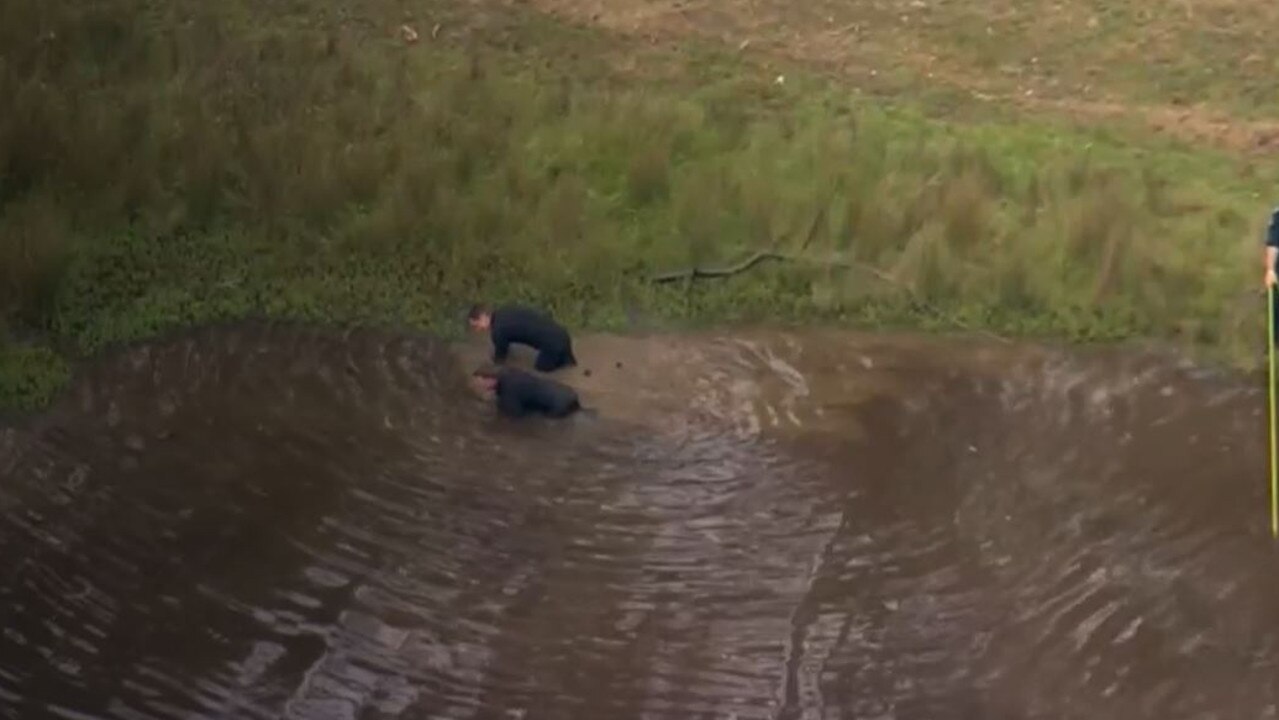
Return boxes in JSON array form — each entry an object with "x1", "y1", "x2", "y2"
[{"x1": 0, "y1": 325, "x2": 1279, "y2": 720}]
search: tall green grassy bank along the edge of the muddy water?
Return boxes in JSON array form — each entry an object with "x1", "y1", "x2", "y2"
[{"x1": 0, "y1": 0, "x2": 1275, "y2": 408}]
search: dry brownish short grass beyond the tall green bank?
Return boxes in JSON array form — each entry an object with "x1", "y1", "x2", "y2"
[{"x1": 516, "y1": 0, "x2": 1279, "y2": 153}]
